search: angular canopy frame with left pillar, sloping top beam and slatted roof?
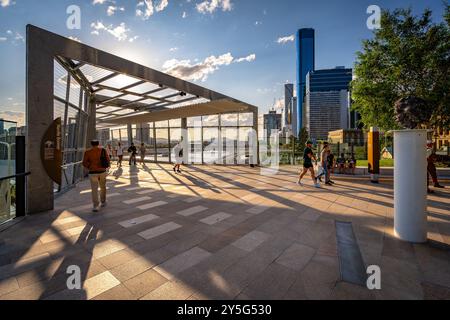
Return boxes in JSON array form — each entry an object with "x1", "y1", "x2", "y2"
[{"x1": 26, "y1": 25, "x2": 258, "y2": 213}]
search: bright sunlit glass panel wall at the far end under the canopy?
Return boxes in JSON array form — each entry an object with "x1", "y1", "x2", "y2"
[{"x1": 103, "y1": 113, "x2": 253, "y2": 165}]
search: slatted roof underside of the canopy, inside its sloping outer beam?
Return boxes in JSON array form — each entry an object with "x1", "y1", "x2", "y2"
[{"x1": 55, "y1": 55, "x2": 258, "y2": 127}]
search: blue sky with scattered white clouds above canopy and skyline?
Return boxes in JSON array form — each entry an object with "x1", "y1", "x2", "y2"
[{"x1": 0, "y1": 0, "x2": 443, "y2": 124}]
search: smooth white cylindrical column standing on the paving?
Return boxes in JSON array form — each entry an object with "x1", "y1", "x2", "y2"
[{"x1": 394, "y1": 130, "x2": 427, "y2": 243}]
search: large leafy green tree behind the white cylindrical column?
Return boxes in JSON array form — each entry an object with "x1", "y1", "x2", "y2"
[{"x1": 351, "y1": 3, "x2": 450, "y2": 130}]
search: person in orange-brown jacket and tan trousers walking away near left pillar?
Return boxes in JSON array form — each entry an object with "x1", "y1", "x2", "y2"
[{"x1": 83, "y1": 140, "x2": 111, "y2": 212}]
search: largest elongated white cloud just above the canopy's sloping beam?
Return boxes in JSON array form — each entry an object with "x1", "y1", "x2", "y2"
[{"x1": 163, "y1": 52, "x2": 256, "y2": 81}]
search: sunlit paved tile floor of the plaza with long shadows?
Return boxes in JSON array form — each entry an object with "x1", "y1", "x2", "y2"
[{"x1": 0, "y1": 164, "x2": 450, "y2": 300}]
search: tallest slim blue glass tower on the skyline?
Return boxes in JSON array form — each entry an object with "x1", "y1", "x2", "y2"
[{"x1": 292, "y1": 29, "x2": 315, "y2": 136}]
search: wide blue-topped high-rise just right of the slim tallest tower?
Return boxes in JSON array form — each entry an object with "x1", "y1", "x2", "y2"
[{"x1": 305, "y1": 67, "x2": 352, "y2": 140}]
